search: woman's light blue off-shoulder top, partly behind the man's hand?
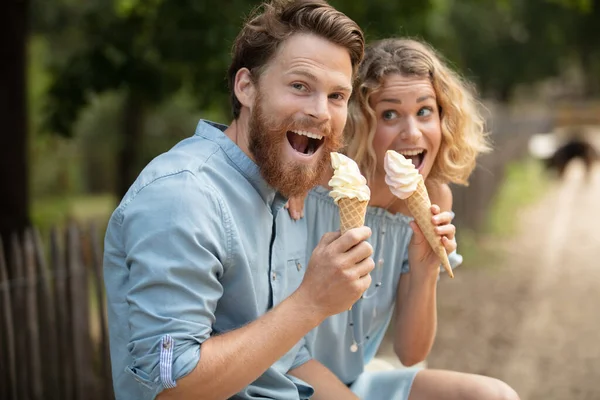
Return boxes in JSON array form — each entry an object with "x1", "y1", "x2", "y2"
[{"x1": 301, "y1": 187, "x2": 462, "y2": 384}]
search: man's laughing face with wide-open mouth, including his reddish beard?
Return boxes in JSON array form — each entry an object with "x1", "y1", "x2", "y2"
[{"x1": 249, "y1": 34, "x2": 352, "y2": 197}]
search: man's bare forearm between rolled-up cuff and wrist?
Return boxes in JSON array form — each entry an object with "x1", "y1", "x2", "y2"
[{"x1": 158, "y1": 292, "x2": 323, "y2": 400}]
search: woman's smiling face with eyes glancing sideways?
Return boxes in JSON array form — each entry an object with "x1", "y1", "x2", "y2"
[{"x1": 369, "y1": 74, "x2": 442, "y2": 179}]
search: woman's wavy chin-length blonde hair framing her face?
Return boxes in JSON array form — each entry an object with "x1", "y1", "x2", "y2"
[{"x1": 344, "y1": 39, "x2": 490, "y2": 185}]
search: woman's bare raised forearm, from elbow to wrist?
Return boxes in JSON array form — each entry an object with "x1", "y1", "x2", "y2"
[{"x1": 394, "y1": 272, "x2": 437, "y2": 366}]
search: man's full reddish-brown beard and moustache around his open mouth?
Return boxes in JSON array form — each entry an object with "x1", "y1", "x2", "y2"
[{"x1": 248, "y1": 96, "x2": 341, "y2": 198}]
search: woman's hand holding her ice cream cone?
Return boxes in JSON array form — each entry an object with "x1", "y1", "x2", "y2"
[{"x1": 408, "y1": 204, "x2": 456, "y2": 271}]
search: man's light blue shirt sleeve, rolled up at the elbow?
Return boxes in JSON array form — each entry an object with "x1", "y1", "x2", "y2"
[{"x1": 121, "y1": 171, "x2": 230, "y2": 397}]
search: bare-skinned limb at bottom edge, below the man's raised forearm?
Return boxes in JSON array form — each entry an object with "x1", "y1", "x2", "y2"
[{"x1": 290, "y1": 360, "x2": 358, "y2": 400}]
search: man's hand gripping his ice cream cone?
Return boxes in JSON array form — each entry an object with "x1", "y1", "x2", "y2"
[{"x1": 298, "y1": 226, "x2": 375, "y2": 318}]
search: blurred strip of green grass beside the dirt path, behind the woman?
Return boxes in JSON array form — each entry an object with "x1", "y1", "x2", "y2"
[{"x1": 457, "y1": 158, "x2": 548, "y2": 267}]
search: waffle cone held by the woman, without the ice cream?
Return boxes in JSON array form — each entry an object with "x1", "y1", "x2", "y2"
[{"x1": 405, "y1": 177, "x2": 454, "y2": 278}]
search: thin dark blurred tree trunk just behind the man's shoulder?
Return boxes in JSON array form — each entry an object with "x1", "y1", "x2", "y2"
[{"x1": 117, "y1": 93, "x2": 144, "y2": 198}]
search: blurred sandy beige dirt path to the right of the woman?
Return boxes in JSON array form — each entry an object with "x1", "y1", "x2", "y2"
[{"x1": 428, "y1": 159, "x2": 600, "y2": 400}]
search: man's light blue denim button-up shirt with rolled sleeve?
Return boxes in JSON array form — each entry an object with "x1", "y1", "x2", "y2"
[{"x1": 104, "y1": 121, "x2": 312, "y2": 400}]
